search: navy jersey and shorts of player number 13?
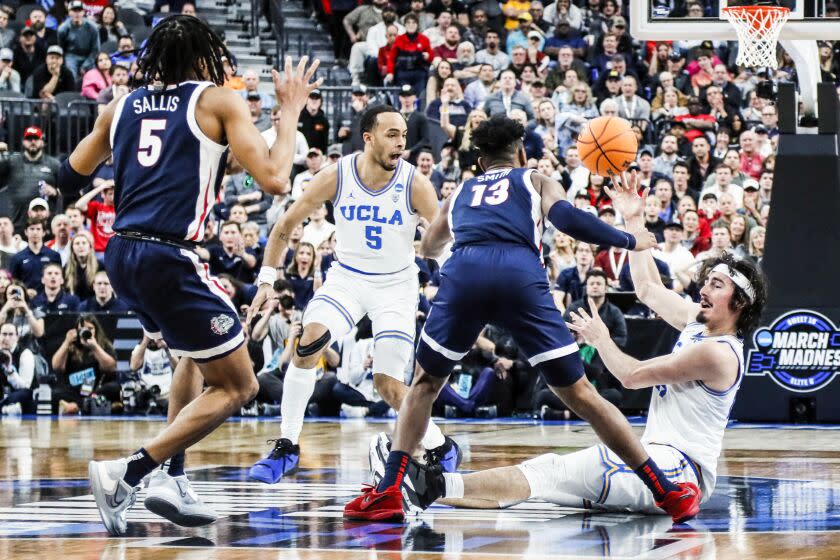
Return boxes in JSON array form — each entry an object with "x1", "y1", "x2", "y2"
[{"x1": 417, "y1": 168, "x2": 583, "y2": 386}]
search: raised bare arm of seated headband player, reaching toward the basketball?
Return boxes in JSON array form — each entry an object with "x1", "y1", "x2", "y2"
[{"x1": 606, "y1": 173, "x2": 700, "y2": 331}]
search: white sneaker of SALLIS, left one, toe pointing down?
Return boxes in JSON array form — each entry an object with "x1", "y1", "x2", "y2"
[{"x1": 88, "y1": 459, "x2": 137, "y2": 537}]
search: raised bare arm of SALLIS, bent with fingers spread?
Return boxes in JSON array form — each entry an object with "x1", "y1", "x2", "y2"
[{"x1": 202, "y1": 56, "x2": 323, "y2": 194}]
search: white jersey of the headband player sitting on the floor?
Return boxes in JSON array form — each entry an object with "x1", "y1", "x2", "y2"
[{"x1": 642, "y1": 323, "x2": 744, "y2": 496}]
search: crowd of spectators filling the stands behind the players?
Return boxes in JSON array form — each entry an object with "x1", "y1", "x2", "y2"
[{"x1": 0, "y1": 0, "x2": 784, "y2": 417}]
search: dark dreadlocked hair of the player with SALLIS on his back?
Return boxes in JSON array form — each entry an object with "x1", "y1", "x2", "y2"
[{"x1": 137, "y1": 14, "x2": 233, "y2": 87}]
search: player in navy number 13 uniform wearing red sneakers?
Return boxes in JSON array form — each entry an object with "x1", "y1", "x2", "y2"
[{"x1": 344, "y1": 116, "x2": 700, "y2": 520}]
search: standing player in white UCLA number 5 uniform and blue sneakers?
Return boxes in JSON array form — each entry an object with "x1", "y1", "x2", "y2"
[{"x1": 248, "y1": 106, "x2": 460, "y2": 483}]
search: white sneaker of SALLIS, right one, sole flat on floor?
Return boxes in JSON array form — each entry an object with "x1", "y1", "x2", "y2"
[{"x1": 143, "y1": 469, "x2": 218, "y2": 527}]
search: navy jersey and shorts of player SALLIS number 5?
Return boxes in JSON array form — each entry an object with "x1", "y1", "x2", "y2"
[{"x1": 105, "y1": 82, "x2": 244, "y2": 361}]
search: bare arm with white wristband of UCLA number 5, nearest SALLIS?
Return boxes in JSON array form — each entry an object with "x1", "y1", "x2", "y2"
[{"x1": 246, "y1": 164, "x2": 338, "y2": 324}]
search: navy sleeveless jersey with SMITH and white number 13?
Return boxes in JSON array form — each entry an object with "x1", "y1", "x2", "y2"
[{"x1": 449, "y1": 168, "x2": 543, "y2": 256}]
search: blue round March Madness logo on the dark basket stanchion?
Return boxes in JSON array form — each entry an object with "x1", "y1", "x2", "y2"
[{"x1": 746, "y1": 309, "x2": 840, "y2": 393}]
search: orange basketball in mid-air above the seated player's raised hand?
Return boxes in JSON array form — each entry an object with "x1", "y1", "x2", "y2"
[{"x1": 577, "y1": 117, "x2": 639, "y2": 177}]
